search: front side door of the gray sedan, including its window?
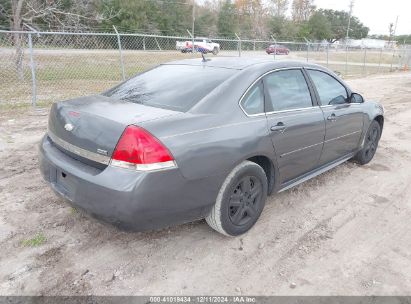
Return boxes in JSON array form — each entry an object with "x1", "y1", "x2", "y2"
[{"x1": 306, "y1": 69, "x2": 363, "y2": 165}]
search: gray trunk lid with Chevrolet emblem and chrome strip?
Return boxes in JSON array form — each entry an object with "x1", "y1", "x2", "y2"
[{"x1": 48, "y1": 95, "x2": 180, "y2": 164}]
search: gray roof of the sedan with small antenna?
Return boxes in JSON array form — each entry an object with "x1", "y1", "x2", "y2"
[{"x1": 163, "y1": 57, "x2": 323, "y2": 70}]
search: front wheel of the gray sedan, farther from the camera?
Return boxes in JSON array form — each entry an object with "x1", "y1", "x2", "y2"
[{"x1": 354, "y1": 120, "x2": 381, "y2": 165}]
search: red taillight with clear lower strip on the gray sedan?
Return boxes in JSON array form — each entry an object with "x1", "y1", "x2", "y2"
[{"x1": 111, "y1": 126, "x2": 176, "y2": 171}]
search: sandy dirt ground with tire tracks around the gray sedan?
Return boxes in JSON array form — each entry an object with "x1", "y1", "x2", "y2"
[{"x1": 0, "y1": 73, "x2": 411, "y2": 295}]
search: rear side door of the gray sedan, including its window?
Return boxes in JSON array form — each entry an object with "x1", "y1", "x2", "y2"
[{"x1": 263, "y1": 69, "x2": 325, "y2": 183}]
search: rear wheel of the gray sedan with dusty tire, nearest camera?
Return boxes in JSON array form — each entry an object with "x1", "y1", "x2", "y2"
[{"x1": 206, "y1": 161, "x2": 268, "y2": 236}]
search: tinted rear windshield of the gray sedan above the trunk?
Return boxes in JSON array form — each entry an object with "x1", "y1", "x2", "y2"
[{"x1": 104, "y1": 64, "x2": 236, "y2": 112}]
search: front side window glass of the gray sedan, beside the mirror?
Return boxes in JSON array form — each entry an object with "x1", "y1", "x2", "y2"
[{"x1": 308, "y1": 70, "x2": 347, "y2": 106}]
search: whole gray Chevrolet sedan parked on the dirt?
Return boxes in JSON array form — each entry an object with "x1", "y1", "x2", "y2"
[{"x1": 39, "y1": 58, "x2": 384, "y2": 236}]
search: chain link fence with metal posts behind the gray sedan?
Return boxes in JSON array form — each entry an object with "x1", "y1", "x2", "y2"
[{"x1": 0, "y1": 31, "x2": 411, "y2": 105}]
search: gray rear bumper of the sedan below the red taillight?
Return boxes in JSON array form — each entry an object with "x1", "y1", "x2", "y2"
[{"x1": 39, "y1": 136, "x2": 219, "y2": 231}]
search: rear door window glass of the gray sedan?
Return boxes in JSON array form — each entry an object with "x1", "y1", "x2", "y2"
[{"x1": 264, "y1": 69, "x2": 313, "y2": 111}]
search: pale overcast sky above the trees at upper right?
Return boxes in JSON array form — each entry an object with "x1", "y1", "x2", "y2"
[{"x1": 314, "y1": 0, "x2": 411, "y2": 35}]
